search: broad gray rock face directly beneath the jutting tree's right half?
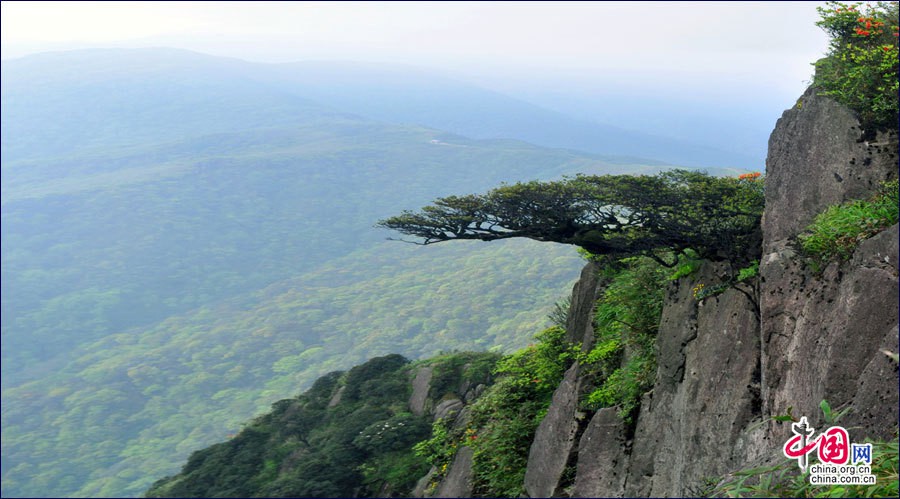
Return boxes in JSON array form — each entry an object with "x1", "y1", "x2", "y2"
[{"x1": 625, "y1": 263, "x2": 760, "y2": 497}]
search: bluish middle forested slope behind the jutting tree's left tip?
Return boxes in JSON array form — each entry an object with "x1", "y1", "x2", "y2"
[{"x1": 2, "y1": 117, "x2": 628, "y2": 383}]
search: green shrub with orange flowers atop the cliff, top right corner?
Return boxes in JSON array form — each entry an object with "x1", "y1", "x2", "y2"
[{"x1": 813, "y1": 2, "x2": 898, "y2": 132}]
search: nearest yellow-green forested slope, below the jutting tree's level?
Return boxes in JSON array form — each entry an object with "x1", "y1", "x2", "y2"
[{"x1": 2, "y1": 240, "x2": 583, "y2": 497}]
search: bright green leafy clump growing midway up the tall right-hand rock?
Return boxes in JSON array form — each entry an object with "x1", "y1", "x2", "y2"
[{"x1": 798, "y1": 180, "x2": 900, "y2": 271}]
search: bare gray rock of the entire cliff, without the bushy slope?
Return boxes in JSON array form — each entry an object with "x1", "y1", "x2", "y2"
[{"x1": 496, "y1": 91, "x2": 898, "y2": 497}]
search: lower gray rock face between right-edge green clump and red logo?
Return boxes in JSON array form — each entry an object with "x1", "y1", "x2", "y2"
[{"x1": 761, "y1": 226, "x2": 900, "y2": 440}]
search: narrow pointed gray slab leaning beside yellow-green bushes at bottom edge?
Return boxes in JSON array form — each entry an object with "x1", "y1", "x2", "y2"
[{"x1": 525, "y1": 364, "x2": 584, "y2": 497}]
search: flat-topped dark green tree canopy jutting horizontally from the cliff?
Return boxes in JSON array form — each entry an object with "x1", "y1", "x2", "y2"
[{"x1": 377, "y1": 170, "x2": 763, "y2": 262}]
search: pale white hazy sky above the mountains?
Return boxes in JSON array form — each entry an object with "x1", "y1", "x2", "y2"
[{"x1": 2, "y1": 1, "x2": 826, "y2": 88}]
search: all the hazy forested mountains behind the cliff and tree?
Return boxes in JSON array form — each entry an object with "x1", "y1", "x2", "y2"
[{"x1": 0, "y1": 49, "x2": 759, "y2": 496}]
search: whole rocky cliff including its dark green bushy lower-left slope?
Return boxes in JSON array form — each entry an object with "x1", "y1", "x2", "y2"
[{"x1": 148, "y1": 91, "x2": 900, "y2": 497}]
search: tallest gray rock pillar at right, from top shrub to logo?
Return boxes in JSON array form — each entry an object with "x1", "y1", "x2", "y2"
[{"x1": 760, "y1": 88, "x2": 898, "y2": 440}]
